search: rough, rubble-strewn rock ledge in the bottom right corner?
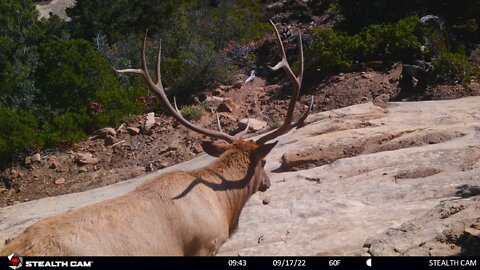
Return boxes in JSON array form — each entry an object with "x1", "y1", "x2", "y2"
[{"x1": 363, "y1": 196, "x2": 480, "y2": 256}]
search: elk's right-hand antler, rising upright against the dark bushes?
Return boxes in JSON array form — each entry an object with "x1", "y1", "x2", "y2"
[{"x1": 256, "y1": 20, "x2": 313, "y2": 144}]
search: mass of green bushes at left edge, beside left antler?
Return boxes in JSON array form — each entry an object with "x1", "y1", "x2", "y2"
[{"x1": 0, "y1": 37, "x2": 145, "y2": 163}]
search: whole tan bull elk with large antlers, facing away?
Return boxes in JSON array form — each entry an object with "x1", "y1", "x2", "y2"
[{"x1": 0, "y1": 22, "x2": 313, "y2": 255}]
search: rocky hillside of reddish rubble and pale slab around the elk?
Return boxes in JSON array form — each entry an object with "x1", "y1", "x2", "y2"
[{"x1": 0, "y1": 0, "x2": 480, "y2": 256}]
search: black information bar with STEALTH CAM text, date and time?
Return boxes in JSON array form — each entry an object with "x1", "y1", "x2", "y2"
[{"x1": 0, "y1": 254, "x2": 480, "y2": 270}]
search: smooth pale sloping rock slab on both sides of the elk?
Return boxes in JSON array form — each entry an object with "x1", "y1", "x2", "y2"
[{"x1": 0, "y1": 97, "x2": 480, "y2": 255}]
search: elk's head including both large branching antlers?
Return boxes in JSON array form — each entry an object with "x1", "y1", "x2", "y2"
[{"x1": 116, "y1": 21, "x2": 313, "y2": 195}]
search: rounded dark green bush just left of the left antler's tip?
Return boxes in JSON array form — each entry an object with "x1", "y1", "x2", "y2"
[{"x1": 36, "y1": 40, "x2": 120, "y2": 112}]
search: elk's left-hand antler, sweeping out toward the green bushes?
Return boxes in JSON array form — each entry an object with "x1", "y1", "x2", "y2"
[{"x1": 115, "y1": 33, "x2": 248, "y2": 143}]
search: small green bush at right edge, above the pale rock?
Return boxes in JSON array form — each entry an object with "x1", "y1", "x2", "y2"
[{"x1": 433, "y1": 51, "x2": 480, "y2": 82}]
